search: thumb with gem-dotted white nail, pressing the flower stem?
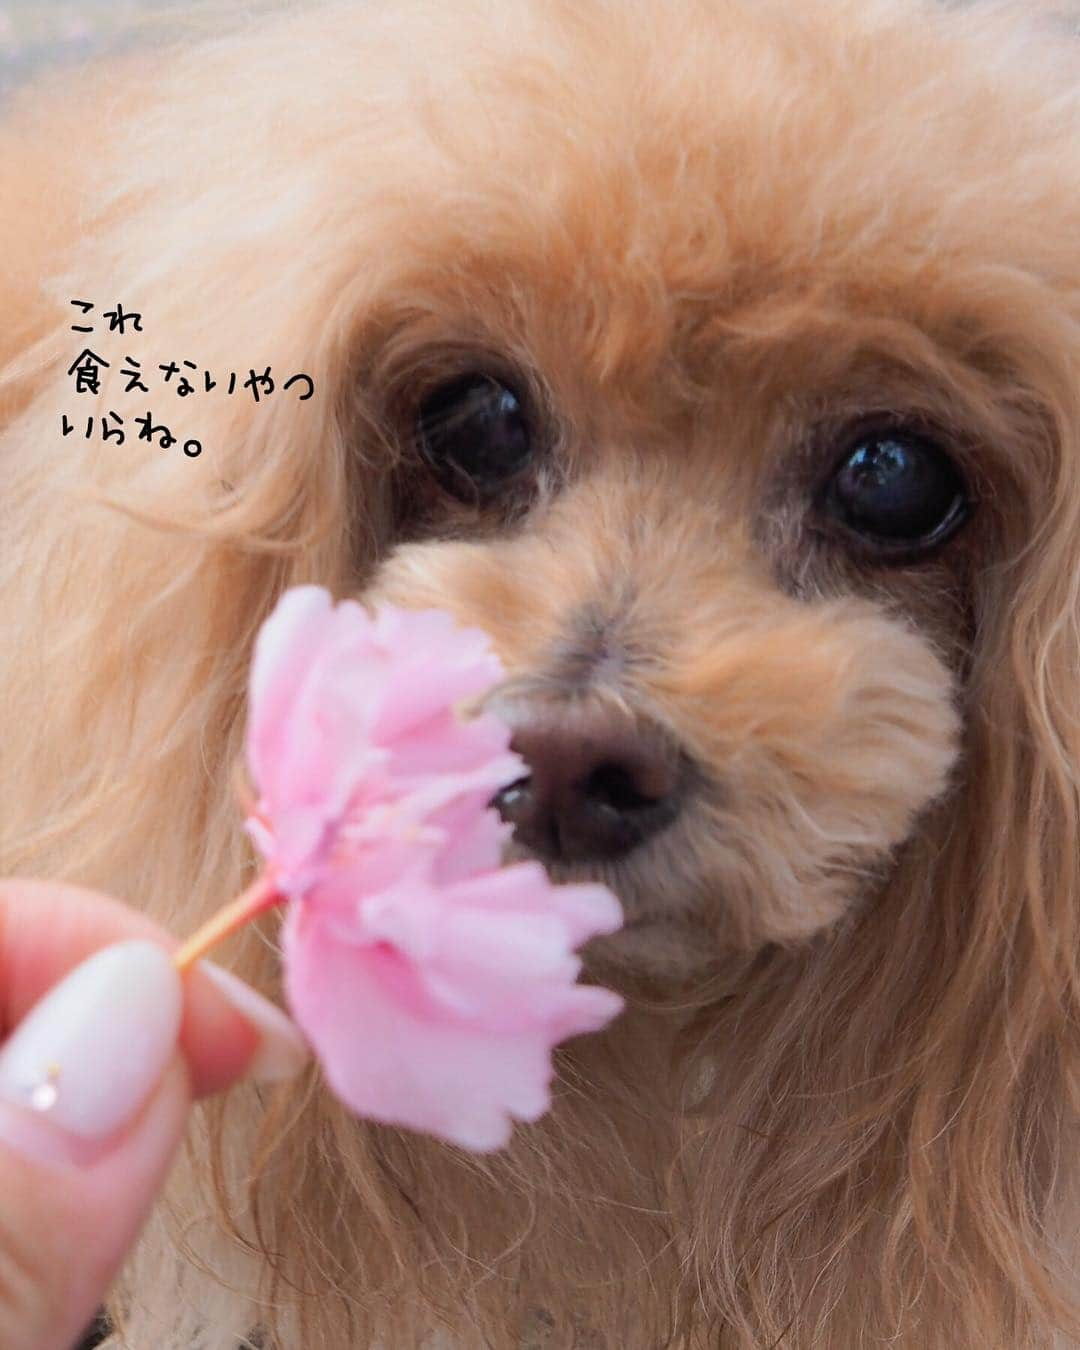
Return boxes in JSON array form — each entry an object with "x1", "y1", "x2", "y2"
[{"x1": 0, "y1": 940, "x2": 192, "y2": 1350}]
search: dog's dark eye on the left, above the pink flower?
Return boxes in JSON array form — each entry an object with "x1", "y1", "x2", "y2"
[{"x1": 416, "y1": 374, "x2": 533, "y2": 500}]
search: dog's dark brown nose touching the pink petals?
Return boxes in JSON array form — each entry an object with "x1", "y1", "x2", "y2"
[{"x1": 491, "y1": 707, "x2": 679, "y2": 863}]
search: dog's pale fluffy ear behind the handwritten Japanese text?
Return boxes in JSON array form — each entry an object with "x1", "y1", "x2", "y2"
[{"x1": 0, "y1": 220, "x2": 387, "y2": 926}]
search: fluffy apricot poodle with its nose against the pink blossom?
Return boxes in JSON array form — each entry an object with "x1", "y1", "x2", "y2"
[{"x1": 0, "y1": 0, "x2": 1080, "y2": 1350}]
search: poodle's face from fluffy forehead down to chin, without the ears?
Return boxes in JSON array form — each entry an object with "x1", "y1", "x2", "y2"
[{"x1": 341, "y1": 5, "x2": 1074, "y2": 975}]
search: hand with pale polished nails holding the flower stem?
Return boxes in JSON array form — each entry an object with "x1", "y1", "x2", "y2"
[{"x1": 0, "y1": 880, "x2": 306, "y2": 1350}]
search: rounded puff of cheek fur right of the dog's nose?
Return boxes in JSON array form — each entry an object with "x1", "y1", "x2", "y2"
[{"x1": 680, "y1": 605, "x2": 959, "y2": 949}]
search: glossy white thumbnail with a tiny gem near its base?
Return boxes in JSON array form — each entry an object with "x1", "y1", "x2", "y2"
[{"x1": 0, "y1": 941, "x2": 184, "y2": 1142}]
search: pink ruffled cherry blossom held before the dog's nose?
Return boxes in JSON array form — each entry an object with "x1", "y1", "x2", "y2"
[{"x1": 240, "y1": 586, "x2": 622, "y2": 1150}]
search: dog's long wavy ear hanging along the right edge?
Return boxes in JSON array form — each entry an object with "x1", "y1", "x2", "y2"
[{"x1": 909, "y1": 332, "x2": 1080, "y2": 1343}]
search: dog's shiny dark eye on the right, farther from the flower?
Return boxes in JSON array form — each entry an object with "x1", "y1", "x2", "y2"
[{"x1": 822, "y1": 431, "x2": 971, "y2": 552}]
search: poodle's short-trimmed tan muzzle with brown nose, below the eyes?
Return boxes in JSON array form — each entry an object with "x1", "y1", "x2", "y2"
[{"x1": 378, "y1": 448, "x2": 956, "y2": 973}]
